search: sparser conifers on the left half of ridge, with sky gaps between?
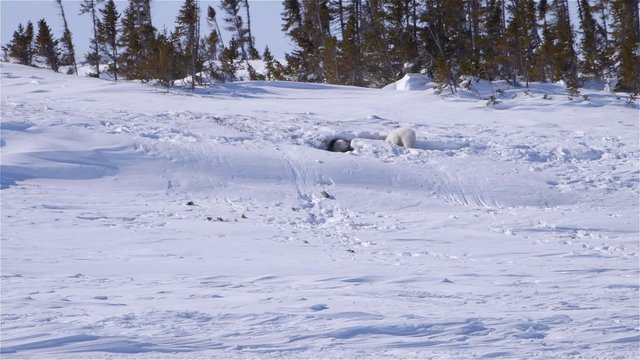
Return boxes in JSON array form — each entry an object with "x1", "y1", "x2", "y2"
[{"x1": 3, "y1": 0, "x2": 285, "y2": 87}]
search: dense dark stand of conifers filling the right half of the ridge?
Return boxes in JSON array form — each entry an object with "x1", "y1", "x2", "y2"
[{"x1": 282, "y1": 0, "x2": 640, "y2": 92}]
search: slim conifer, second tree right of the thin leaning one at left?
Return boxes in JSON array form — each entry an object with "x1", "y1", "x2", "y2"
[{"x1": 96, "y1": 0, "x2": 120, "y2": 81}]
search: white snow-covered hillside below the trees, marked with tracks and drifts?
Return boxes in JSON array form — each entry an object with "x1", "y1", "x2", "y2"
[{"x1": 0, "y1": 63, "x2": 640, "y2": 359}]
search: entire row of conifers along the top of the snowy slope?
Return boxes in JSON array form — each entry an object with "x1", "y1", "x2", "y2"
[{"x1": 3, "y1": 0, "x2": 640, "y2": 93}]
